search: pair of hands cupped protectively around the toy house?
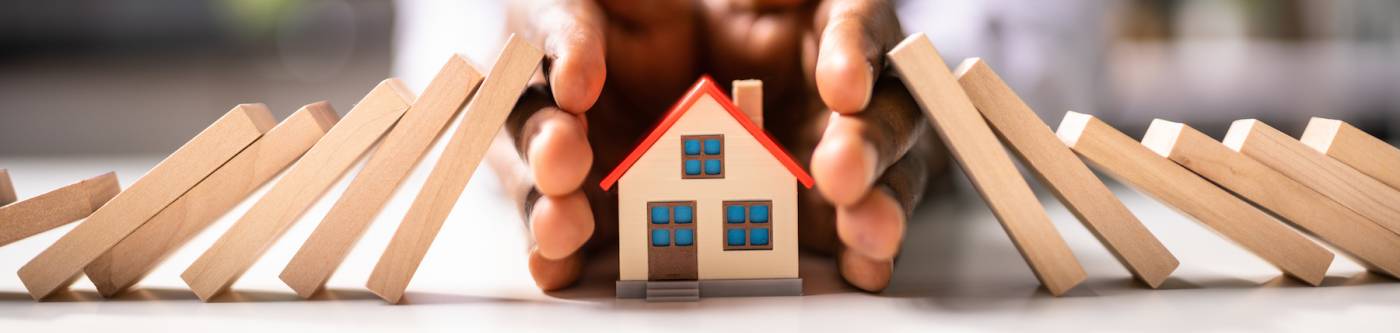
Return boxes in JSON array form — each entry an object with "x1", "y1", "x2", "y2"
[{"x1": 507, "y1": 0, "x2": 946, "y2": 291}]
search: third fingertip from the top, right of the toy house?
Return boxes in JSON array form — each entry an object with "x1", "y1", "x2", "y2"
[{"x1": 836, "y1": 190, "x2": 906, "y2": 259}]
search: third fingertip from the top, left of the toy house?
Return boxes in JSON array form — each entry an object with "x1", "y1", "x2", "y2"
[{"x1": 529, "y1": 192, "x2": 594, "y2": 260}]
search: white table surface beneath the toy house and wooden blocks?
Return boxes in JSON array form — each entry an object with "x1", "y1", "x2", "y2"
[{"x1": 0, "y1": 147, "x2": 1400, "y2": 332}]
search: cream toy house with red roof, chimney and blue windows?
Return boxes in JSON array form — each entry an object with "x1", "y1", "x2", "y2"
[{"x1": 601, "y1": 77, "x2": 812, "y2": 301}]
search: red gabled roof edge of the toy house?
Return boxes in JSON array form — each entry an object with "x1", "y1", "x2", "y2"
[{"x1": 598, "y1": 76, "x2": 812, "y2": 190}]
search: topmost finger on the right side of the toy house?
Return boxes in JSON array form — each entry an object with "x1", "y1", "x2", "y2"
[{"x1": 815, "y1": 0, "x2": 902, "y2": 113}]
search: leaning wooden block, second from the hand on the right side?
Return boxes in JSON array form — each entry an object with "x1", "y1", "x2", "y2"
[{"x1": 955, "y1": 57, "x2": 1179, "y2": 288}]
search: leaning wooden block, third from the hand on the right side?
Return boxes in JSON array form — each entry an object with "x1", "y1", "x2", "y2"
[{"x1": 1056, "y1": 112, "x2": 1333, "y2": 285}]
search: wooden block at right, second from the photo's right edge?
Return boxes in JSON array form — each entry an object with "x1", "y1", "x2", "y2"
[{"x1": 1225, "y1": 119, "x2": 1400, "y2": 232}]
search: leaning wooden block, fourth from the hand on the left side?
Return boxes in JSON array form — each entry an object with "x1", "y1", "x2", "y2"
[{"x1": 84, "y1": 108, "x2": 339, "y2": 297}]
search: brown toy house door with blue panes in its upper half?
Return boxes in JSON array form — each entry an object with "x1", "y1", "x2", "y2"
[{"x1": 647, "y1": 201, "x2": 700, "y2": 280}]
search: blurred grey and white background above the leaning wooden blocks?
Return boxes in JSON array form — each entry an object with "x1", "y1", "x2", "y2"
[{"x1": 0, "y1": 0, "x2": 1400, "y2": 156}]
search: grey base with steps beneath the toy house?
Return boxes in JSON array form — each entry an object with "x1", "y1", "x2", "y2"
[{"x1": 617, "y1": 278, "x2": 802, "y2": 302}]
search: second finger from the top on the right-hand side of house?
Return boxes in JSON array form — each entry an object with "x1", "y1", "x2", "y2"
[{"x1": 811, "y1": 76, "x2": 928, "y2": 206}]
